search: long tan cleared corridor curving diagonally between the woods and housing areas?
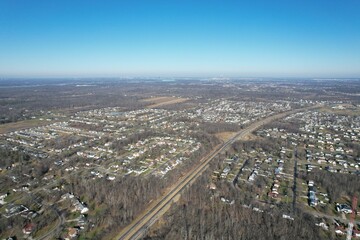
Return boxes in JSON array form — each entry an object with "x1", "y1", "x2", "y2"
[{"x1": 115, "y1": 106, "x2": 319, "y2": 240}]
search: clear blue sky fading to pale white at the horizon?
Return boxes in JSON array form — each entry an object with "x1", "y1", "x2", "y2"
[{"x1": 0, "y1": 0, "x2": 360, "y2": 77}]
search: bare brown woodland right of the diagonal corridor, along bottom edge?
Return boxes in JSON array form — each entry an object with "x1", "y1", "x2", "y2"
[{"x1": 146, "y1": 172, "x2": 331, "y2": 240}]
